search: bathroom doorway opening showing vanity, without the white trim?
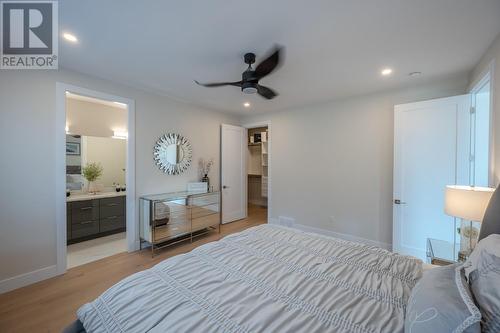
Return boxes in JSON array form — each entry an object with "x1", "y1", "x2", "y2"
[{"x1": 66, "y1": 92, "x2": 128, "y2": 268}]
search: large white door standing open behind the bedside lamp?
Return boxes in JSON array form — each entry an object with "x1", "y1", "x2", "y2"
[{"x1": 393, "y1": 95, "x2": 471, "y2": 260}]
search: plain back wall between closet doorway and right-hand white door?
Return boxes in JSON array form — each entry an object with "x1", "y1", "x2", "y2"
[{"x1": 243, "y1": 74, "x2": 467, "y2": 247}]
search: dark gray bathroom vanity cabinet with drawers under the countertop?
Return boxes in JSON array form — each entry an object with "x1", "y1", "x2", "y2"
[{"x1": 66, "y1": 196, "x2": 126, "y2": 244}]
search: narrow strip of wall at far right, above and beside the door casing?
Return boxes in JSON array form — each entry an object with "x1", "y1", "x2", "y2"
[{"x1": 469, "y1": 34, "x2": 500, "y2": 186}]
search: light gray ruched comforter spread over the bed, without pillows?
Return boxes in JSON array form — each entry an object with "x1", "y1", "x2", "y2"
[{"x1": 78, "y1": 225, "x2": 422, "y2": 333}]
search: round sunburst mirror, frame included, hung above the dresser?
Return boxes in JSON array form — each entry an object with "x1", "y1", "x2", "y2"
[{"x1": 154, "y1": 133, "x2": 192, "y2": 175}]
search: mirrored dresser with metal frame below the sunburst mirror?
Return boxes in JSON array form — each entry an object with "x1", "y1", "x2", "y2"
[{"x1": 139, "y1": 191, "x2": 221, "y2": 256}]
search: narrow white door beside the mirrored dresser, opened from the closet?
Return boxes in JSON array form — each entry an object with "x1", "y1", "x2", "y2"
[{"x1": 221, "y1": 124, "x2": 247, "y2": 223}]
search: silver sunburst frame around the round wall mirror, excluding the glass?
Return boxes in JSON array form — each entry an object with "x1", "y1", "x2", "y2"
[{"x1": 153, "y1": 133, "x2": 193, "y2": 175}]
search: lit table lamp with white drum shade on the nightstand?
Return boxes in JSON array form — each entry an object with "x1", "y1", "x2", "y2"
[{"x1": 444, "y1": 185, "x2": 495, "y2": 258}]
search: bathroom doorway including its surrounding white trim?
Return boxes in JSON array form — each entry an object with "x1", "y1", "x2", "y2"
[{"x1": 57, "y1": 84, "x2": 137, "y2": 273}]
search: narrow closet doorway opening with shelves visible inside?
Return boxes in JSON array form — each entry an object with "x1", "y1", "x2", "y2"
[{"x1": 247, "y1": 126, "x2": 270, "y2": 220}]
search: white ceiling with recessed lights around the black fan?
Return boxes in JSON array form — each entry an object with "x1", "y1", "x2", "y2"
[{"x1": 59, "y1": 0, "x2": 500, "y2": 114}]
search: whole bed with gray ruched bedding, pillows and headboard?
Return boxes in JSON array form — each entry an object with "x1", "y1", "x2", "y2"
[{"x1": 65, "y1": 188, "x2": 500, "y2": 333}]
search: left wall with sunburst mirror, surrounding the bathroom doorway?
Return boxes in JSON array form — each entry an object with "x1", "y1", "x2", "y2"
[{"x1": 0, "y1": 70, "x2": 238, "y2": 292}]
